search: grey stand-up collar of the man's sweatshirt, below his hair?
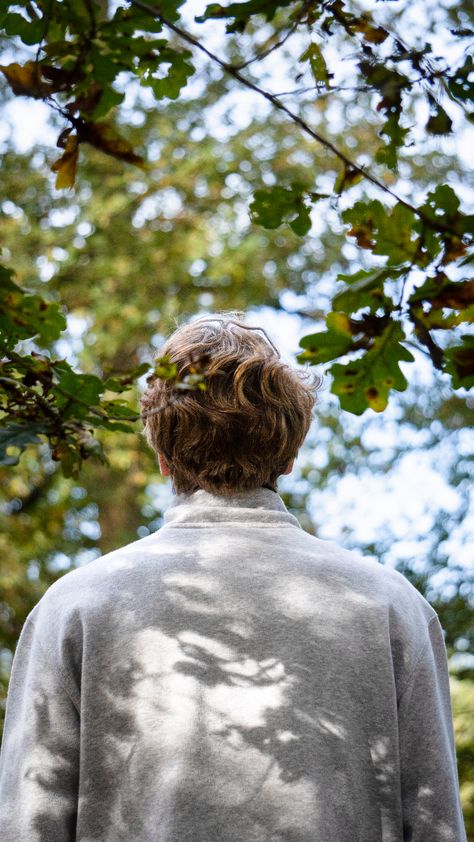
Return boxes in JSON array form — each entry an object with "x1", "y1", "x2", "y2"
[{"x1": 164, "y1": 488, "x2": 300, "y2": 528}]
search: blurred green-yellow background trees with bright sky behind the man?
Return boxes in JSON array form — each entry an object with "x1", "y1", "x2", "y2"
[{"x1": 0, "y1": 2, "x2": 474, "y2": 835}]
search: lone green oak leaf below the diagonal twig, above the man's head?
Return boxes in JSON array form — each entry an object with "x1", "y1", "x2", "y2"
[{"x1": 250, "y1": 184, "x2": 311, "y2": 237}]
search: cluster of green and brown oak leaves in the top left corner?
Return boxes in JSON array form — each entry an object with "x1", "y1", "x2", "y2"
[{"x1": 0, "y1": 0, "x2": 194, "y2": 189}]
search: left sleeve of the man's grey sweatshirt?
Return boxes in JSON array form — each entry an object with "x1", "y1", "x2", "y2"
[{"x1": 0, "y1": 612, "x2": 79, "y2": 842}]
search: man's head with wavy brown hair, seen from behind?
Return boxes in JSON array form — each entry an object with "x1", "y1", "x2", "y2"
[{"x1": 141, "y1": 314, "x2": 317, "y2": 494}]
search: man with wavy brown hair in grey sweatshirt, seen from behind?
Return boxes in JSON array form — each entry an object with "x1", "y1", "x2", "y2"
[{"x1": 0, "y1": 316, "x2": 465, "y2": 842}]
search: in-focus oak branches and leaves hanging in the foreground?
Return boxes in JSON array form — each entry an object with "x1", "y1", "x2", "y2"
[{"x1": 1, "y1": 0, "x2": 474, "y2": 472}]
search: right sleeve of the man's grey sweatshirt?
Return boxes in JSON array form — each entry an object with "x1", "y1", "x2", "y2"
[{"x1": 399, "y1": 616, "x2": 466, "y2": 842}]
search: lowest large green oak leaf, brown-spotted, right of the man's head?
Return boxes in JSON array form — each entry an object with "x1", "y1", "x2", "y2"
[{"x1": 330, "y1": 322, "x2": 414, "y2": 415}]
